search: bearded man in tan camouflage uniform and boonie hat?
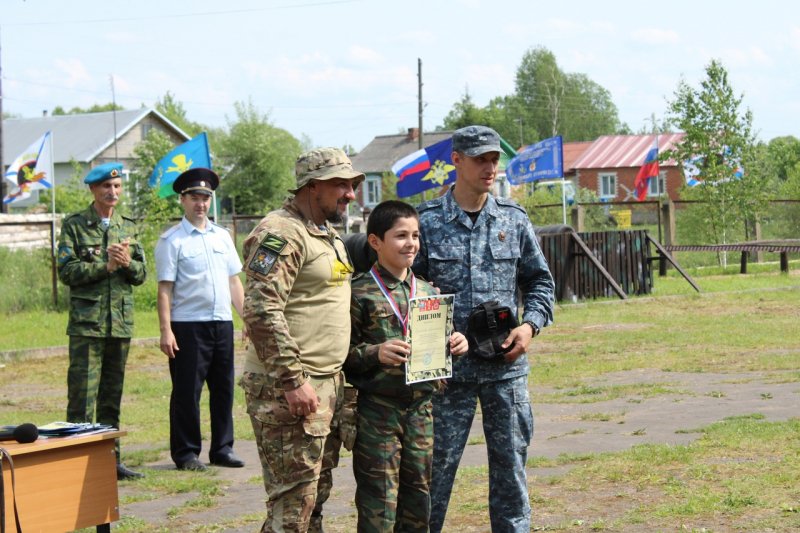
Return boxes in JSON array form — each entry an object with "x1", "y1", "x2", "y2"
[{"x1": 242, "y1": 148, "x2": 364, "y2": 531}]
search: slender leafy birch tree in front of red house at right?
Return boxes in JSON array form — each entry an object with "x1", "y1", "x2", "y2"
[{"x1": 662, "y1": 60, "x2": 767, "y2": 256}]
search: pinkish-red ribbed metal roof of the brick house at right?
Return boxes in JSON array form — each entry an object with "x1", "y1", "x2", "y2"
[{"x1": 564, "y1": 133, "x2": 684, "y2": 170}]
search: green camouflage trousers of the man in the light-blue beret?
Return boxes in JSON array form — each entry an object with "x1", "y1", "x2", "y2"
[{"x1": 67, "y1": 335, "x2": 131, "y2": 462}]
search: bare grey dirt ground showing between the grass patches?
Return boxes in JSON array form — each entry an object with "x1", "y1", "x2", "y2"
[{"x1": 115, "y1": 371, "x2": 800, "y2": 532}]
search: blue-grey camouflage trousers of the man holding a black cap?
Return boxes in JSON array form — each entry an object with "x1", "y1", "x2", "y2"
[{"x1": 431, "y1": 375, "x2": 533, "y2": 533}]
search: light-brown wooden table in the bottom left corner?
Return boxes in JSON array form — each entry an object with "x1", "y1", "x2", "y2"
[{"x1": 0, "y1": 431, "x2": 125, "y2": 533}]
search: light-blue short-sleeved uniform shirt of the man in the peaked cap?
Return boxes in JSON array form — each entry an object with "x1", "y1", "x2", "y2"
[{"x1": 155, "y1": 217, "x2": 242, "y2": 322}]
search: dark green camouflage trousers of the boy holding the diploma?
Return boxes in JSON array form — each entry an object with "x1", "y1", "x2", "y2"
[{"x1": 353, "y1": 393, "x2": 433, "y2": 532}]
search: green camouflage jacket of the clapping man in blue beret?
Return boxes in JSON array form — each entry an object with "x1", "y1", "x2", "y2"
[{"x1": 58, "y1": 205, "x2": 146, "y2": 338}]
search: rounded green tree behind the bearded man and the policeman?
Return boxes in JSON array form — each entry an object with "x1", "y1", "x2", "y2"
[{"x1": 217, "y1": 102, "x2": 301, "y2": 214}]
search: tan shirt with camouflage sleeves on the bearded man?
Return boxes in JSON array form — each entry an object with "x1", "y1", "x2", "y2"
[{"x1": 243, "y1": 202, "x2": 353, "y2": 390}]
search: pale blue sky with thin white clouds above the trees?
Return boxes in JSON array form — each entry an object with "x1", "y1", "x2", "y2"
[{"x1": 0, "y1": 0, "x2": 800, "y2": 150}]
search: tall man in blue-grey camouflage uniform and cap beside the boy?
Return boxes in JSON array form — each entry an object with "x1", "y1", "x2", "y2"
[{"x1": 414, "y1": 126, "x2": 554, "y2": 532}]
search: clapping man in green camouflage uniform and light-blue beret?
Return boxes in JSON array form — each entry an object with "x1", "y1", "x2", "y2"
[{"x1": 58, "y1": 163, "x2": 145, "y2": 479}]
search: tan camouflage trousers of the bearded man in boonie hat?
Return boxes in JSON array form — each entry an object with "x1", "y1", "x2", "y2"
[{"x1": 241, "y1": 372, "x2": 344, "y2": 532}]
